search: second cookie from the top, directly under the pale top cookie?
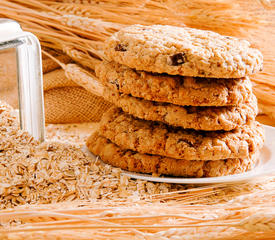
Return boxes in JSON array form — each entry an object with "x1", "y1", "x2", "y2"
[{"x1": 95, "y1": 61, "x2": 252, "y2": 106}]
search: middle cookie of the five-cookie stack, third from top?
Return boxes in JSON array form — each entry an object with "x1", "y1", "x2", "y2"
[{"x1": 103, "y1": 88, "x2": 258, "y2": 131}]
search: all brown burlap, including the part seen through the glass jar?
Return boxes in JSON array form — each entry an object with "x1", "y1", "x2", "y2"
[{"x1": 0, "y1": 51, "x2": 110, "y2": 123}]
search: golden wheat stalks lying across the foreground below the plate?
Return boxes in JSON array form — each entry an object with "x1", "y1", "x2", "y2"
[{"x1": 0, "y1": 184, "x2": 275, "y2": 239}]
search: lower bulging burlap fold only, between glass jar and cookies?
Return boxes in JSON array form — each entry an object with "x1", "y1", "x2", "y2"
[{"x1": 44, "y1": 87, "x2": 111, "y2": 123}]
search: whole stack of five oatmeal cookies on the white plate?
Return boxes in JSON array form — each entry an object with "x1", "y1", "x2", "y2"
[{"x1": 87, "y1": 25, "x2": 264, "y2": 177}]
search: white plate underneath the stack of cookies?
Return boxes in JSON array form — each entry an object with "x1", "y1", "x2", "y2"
[{"x1": 83, "y1": 126, "x2": 275, "y2": 184}]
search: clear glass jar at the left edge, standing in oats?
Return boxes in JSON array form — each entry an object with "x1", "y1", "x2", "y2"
[{"x1": 0, "y1": 18, "x2": 45, "y2": 141}]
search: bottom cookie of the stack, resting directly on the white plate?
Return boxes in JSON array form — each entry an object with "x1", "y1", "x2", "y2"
[{"x1": 87, "y1": 132, "x2": 259, "y2": 177}]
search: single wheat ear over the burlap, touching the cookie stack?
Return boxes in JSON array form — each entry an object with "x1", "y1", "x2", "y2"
[{"x1": 64, "y1": 64, "x2": 104, "y2": 96}]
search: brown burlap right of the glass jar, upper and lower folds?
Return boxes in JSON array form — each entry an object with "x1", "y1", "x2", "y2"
[{"x1": 43, "y1": 62, "x2": 111, "y2": 123}]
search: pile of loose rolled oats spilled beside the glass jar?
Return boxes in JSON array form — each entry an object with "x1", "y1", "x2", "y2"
[{"x1": 0, "y1": 100, "x2": 190, "y2": 208}]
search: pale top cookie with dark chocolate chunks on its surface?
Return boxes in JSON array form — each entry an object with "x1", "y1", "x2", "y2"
[{"x1": 105, "y1": 25, "x2": 263, "y2": 78}]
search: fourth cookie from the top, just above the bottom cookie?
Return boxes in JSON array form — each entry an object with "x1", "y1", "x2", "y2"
[{"x1": 99, "y1": 107, "x2": 264, "y2": 160}]
